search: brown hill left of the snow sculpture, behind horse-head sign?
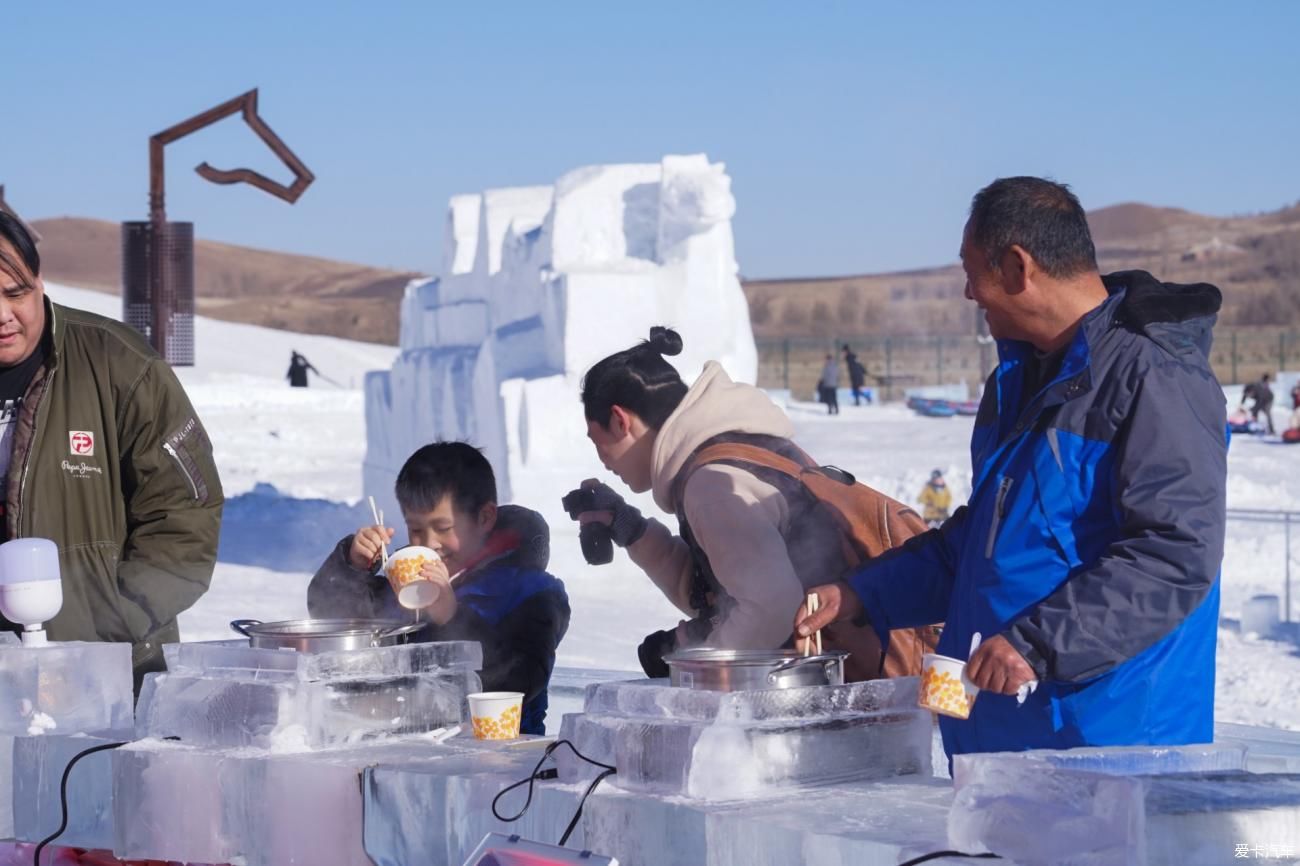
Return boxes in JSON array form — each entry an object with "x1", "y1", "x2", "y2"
[{"x1": 33, "y1": 217, "x2": 416, "y2": 345}]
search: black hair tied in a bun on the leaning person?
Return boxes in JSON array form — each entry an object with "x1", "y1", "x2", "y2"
[{"x1": 582, "y1": 325, "x2": 689, "y2": 430}]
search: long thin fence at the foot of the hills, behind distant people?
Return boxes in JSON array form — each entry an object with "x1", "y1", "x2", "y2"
[{"x1": 757, "y1": 328, "x2": 1300, "y2": 400}]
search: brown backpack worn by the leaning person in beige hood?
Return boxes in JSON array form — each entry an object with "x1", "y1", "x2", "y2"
[{"x1": 684, "y1": 442, "x2": 940, "y2": 681}]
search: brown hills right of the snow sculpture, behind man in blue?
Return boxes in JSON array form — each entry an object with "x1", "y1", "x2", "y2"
[{"x1": 742, "y1": 204, "x2": 1300, "y2": 338}]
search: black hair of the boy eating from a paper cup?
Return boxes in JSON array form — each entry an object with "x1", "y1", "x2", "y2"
[{"x1": 397, "y1": 442, "x2": 497, "y2": 515}]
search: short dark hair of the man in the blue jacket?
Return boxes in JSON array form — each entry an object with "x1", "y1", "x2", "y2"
[{"x1": 967, "y1": 177, "x2": 1097, "y2": 280}]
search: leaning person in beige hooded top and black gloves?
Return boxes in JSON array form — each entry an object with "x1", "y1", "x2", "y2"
[{"x1": 564, "y1": 328, "x2": 846, "y2": 676}]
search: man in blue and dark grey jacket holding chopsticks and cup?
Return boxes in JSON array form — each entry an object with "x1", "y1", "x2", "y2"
[{"x1": 797, "y1": 177, "x2": 1227, "y2": 754}]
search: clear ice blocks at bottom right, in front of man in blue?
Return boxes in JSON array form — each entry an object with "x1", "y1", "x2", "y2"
[{"x1": 948, "y1": 745, "x2": 1300, "y2": 866}]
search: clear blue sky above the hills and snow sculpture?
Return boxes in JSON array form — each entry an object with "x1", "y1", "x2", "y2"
[{"x1": 0, "y1": 0, "x2": 1300, "y2": 277}]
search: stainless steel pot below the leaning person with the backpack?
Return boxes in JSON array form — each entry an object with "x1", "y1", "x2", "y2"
[{"x1": 663, "y1": 648, "x2": 849, "y2": 692}]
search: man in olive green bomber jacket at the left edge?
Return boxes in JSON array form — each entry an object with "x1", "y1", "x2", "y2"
[{"x1": 0, "y1": 213, "x2": 222, "y2": 688}]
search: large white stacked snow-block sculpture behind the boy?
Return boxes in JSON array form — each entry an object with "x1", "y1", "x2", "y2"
[{"x1": 365, "y1": 155, "x2": 758, "y2": 514}]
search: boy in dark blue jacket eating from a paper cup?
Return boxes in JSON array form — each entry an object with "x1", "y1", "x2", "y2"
[{"x1": 307, "y1": 442, "x2": 569, "y2": 733}]
